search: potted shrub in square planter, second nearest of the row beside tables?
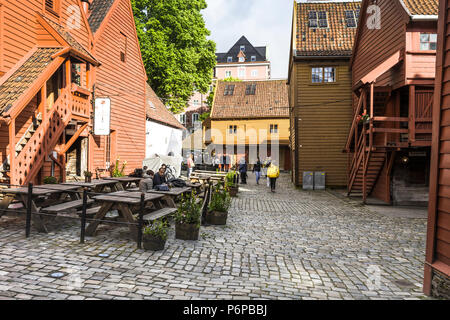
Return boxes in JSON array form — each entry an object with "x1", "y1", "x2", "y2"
[{"x1": 175, "y1": 192, "x2": 202, "y2": 240}]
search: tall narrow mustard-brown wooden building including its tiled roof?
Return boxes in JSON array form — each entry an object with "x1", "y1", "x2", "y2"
[{"x1": 288, "y1": 1, "x2": 360, "y2": 187}]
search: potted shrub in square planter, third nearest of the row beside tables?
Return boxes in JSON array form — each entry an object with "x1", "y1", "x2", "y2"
[{"x1": 206, "y1": 185, "x2": 231, "y2": 225}]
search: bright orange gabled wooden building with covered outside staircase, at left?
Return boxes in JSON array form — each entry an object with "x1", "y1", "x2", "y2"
[{"x1": 0, "y1": 0, "x2": 146, "y2": 184}]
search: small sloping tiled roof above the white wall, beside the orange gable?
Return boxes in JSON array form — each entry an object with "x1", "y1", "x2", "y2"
[{"x1": 145, "y1": 84, "x2": 185, "y2": 130}]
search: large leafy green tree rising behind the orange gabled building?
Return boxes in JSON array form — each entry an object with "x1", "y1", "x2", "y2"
[{"x1": 131, "y1": 0, "x2": 216, "y2": 113}]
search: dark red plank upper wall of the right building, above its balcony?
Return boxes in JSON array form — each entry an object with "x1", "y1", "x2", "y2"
[{"x1": 352, "y1": 0, "x2": 406, "y2": 87}]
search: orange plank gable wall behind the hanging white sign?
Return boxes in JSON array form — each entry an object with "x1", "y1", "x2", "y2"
[{"x1": 90, "y1": 0, "x2": 146, "y2": 173}]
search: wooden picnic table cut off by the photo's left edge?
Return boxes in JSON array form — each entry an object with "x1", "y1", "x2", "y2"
[{"x1": 0, "y1": 184, "x2": 79, "y2": 233}]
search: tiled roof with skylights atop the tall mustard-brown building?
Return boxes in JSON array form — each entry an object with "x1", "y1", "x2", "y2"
[{"x1": 293, "y1": 1, "x2": 361, "y2": 57}]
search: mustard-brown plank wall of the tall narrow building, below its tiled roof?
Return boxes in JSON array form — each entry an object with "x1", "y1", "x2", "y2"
[{"x1": 295, "y1": 59, "x2": 353, "y2": 186}]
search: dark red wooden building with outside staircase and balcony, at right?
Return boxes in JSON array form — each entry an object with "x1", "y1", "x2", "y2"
[{"x1": 345, "y1": 0, "x2": 438, "y2": 205}]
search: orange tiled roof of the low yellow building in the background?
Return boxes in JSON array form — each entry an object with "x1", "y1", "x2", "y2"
[{"x1": 211, "y1": 79, "x2": 289, "y2": 120}]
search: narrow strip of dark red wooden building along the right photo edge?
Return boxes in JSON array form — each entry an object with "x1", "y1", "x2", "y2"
[{"x1": 424, "y1": 0, "x2": 450, "y2": 299}]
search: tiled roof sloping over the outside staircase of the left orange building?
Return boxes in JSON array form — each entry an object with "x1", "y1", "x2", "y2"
[{"x1": 0, "y1": 48, "x2": 61, "y2": 114}]
